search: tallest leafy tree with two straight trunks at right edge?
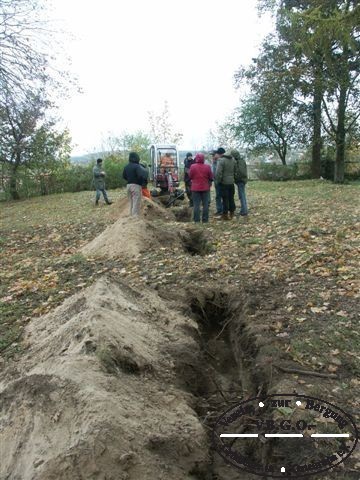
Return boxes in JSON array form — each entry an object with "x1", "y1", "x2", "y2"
[{"x1": 258, "y1": 0, "x2": 360, "y2": 182}]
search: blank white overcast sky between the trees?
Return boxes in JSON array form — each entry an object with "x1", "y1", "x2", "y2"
[{"x1": 51, "y1": 0, "x2": 271, "y2": 155}]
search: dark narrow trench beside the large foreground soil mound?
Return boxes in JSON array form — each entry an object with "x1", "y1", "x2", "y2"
[{"x1": 186, "y1": 291, "x2": 267, "y2": 480}]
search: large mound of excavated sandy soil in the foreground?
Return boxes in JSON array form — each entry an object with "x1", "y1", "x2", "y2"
[{"x1": 0, "y1": 279, "x2": 207, "y2": 480}]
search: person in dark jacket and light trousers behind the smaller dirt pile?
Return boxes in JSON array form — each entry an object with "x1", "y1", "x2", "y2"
[{"x1": 123, "y1": 152, "x2": 148, "y2": 217}]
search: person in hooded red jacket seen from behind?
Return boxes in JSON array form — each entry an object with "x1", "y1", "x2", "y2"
[{"x1": 189, "y1": 153, "x2": 214, "y2": 223}]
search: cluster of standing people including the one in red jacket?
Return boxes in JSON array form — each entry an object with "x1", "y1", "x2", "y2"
[{"x1": 184, "y1": 147, "x2": 248, "y2": 223}]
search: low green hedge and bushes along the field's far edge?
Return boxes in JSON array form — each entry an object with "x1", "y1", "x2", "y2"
[{"x1": 0, "y1": 151, "x2": 360, "y2": 200}]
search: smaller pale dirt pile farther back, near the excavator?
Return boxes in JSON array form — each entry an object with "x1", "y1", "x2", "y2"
[{"x1": 81, "y1": 198, "x2": 182, "y2": 258}]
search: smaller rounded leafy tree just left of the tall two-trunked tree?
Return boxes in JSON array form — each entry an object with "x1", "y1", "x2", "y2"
[{"x1": 233, "y1": 36, "x2": 308, "y2": 165}]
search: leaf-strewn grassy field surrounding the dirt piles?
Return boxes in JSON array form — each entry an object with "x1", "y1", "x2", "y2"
[{"x1": 0, "y1": 181, "x2": 360, "y2": 382}]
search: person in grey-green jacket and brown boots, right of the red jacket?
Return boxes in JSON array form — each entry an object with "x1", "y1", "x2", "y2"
[{"x1": 215, "y1": 151, "x2": 237, "y2": 220}]
